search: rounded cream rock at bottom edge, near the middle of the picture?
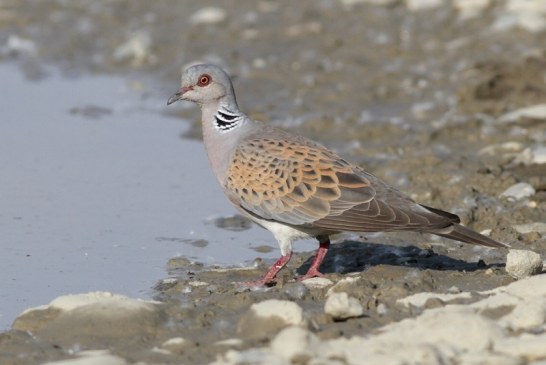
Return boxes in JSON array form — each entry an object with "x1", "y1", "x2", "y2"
[{"x1": 270, "y1": 326, "x2": 323, "y2": 360}]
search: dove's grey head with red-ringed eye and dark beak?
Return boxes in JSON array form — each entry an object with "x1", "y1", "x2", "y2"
[{"x1": 167, "y1": 64, "x2": 238, "y2": 110}]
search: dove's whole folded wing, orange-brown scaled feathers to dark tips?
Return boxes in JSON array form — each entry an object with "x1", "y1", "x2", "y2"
[{"x1": 225, "y1": 135, "x2": 451, "y2": 232}]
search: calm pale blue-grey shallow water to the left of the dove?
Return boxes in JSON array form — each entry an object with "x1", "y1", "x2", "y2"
[{"x1": 0, "y1": 64, "x2": 315, "y2": 329}]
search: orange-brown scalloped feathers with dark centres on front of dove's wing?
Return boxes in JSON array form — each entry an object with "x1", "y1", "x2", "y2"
[{"x1": 226, "y1": 135, "x2": 375, "y2": 225}]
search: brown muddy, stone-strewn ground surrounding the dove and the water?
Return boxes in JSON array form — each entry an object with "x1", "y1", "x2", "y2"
[{"x1": 0, "y1": 0, "x2": 546, "y2": 364}]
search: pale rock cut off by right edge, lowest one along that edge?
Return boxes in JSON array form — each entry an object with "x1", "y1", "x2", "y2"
[{"x1": 500, "y1": 297, "x2": 546, "y2": 331}]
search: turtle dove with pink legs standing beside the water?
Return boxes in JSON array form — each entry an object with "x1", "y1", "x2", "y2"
[{"x1": 167, "y1": 64, "x2": 510, "y2": 287}]
